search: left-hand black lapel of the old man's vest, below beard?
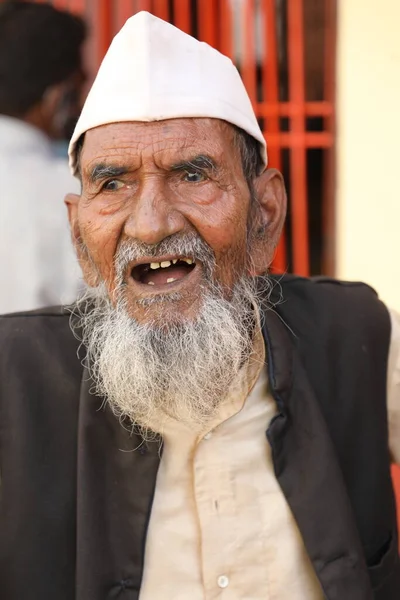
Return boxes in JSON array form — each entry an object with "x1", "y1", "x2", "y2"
[{"x1": 76, "y1": 367, "x2": 160, "y2": 600}]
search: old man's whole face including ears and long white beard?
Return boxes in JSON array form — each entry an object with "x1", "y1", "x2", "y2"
[{"x1": 66, "y1": 119, "x2": 285, "y2": 432}]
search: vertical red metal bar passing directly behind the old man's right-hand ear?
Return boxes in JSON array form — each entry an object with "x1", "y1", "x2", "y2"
[{"x1": 262, "y1": 0, "x2": 287, "y2": 272}]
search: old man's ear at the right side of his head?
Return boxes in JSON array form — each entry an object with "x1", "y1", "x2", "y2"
[{"x1": 249, "y1": 169, "x2": 287, "y2": 276}]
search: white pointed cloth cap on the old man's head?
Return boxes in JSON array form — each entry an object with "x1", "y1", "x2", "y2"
[{"x1": 68, "y1": 11, "x2": 267, "y2": 175}]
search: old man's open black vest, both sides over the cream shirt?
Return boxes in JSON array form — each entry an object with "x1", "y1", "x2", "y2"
[{"x1": 0, "y1": 276, "x2": 400, "y2": 600}]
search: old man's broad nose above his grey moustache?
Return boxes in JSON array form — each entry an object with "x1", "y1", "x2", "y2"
[{"x1": 124, "y1": 181, "x2": 185, "y2": 244}]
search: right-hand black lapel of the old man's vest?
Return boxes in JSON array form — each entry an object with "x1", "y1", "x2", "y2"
[{"x1": 263, "y1": 309, "x2": 373, "y2": 600}]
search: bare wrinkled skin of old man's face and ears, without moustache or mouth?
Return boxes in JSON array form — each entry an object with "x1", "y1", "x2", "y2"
[{"x1": 66, "y1": 118, "x2": 286, "y2": 322}]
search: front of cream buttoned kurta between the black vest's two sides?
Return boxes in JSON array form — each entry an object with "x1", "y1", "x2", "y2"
[{"x1": 140, "y1": 333, "x2": 323, "y2": 600}]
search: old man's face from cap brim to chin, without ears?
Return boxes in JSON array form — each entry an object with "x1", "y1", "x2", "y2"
[{"x1": 70, "y1": 118, "x2": 256, "y2": 323}]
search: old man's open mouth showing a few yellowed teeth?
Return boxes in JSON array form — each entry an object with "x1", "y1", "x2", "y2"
[{"x1": 131, "y1": 257, "x2": 196, "y2": 286}]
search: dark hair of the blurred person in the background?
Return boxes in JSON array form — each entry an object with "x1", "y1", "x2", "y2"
[{"x1": 0, "y1": 0, "x2": 86, "y2": 117}]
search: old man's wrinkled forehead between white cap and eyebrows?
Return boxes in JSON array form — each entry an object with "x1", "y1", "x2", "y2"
[{"x1": 80, "y1": 118, "x2": 234, "y2": 170}]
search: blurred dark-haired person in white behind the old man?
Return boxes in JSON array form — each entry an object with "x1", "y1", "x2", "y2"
[{"x1": 0, "y1": 2, "x2": 86, "y2": 313}]
